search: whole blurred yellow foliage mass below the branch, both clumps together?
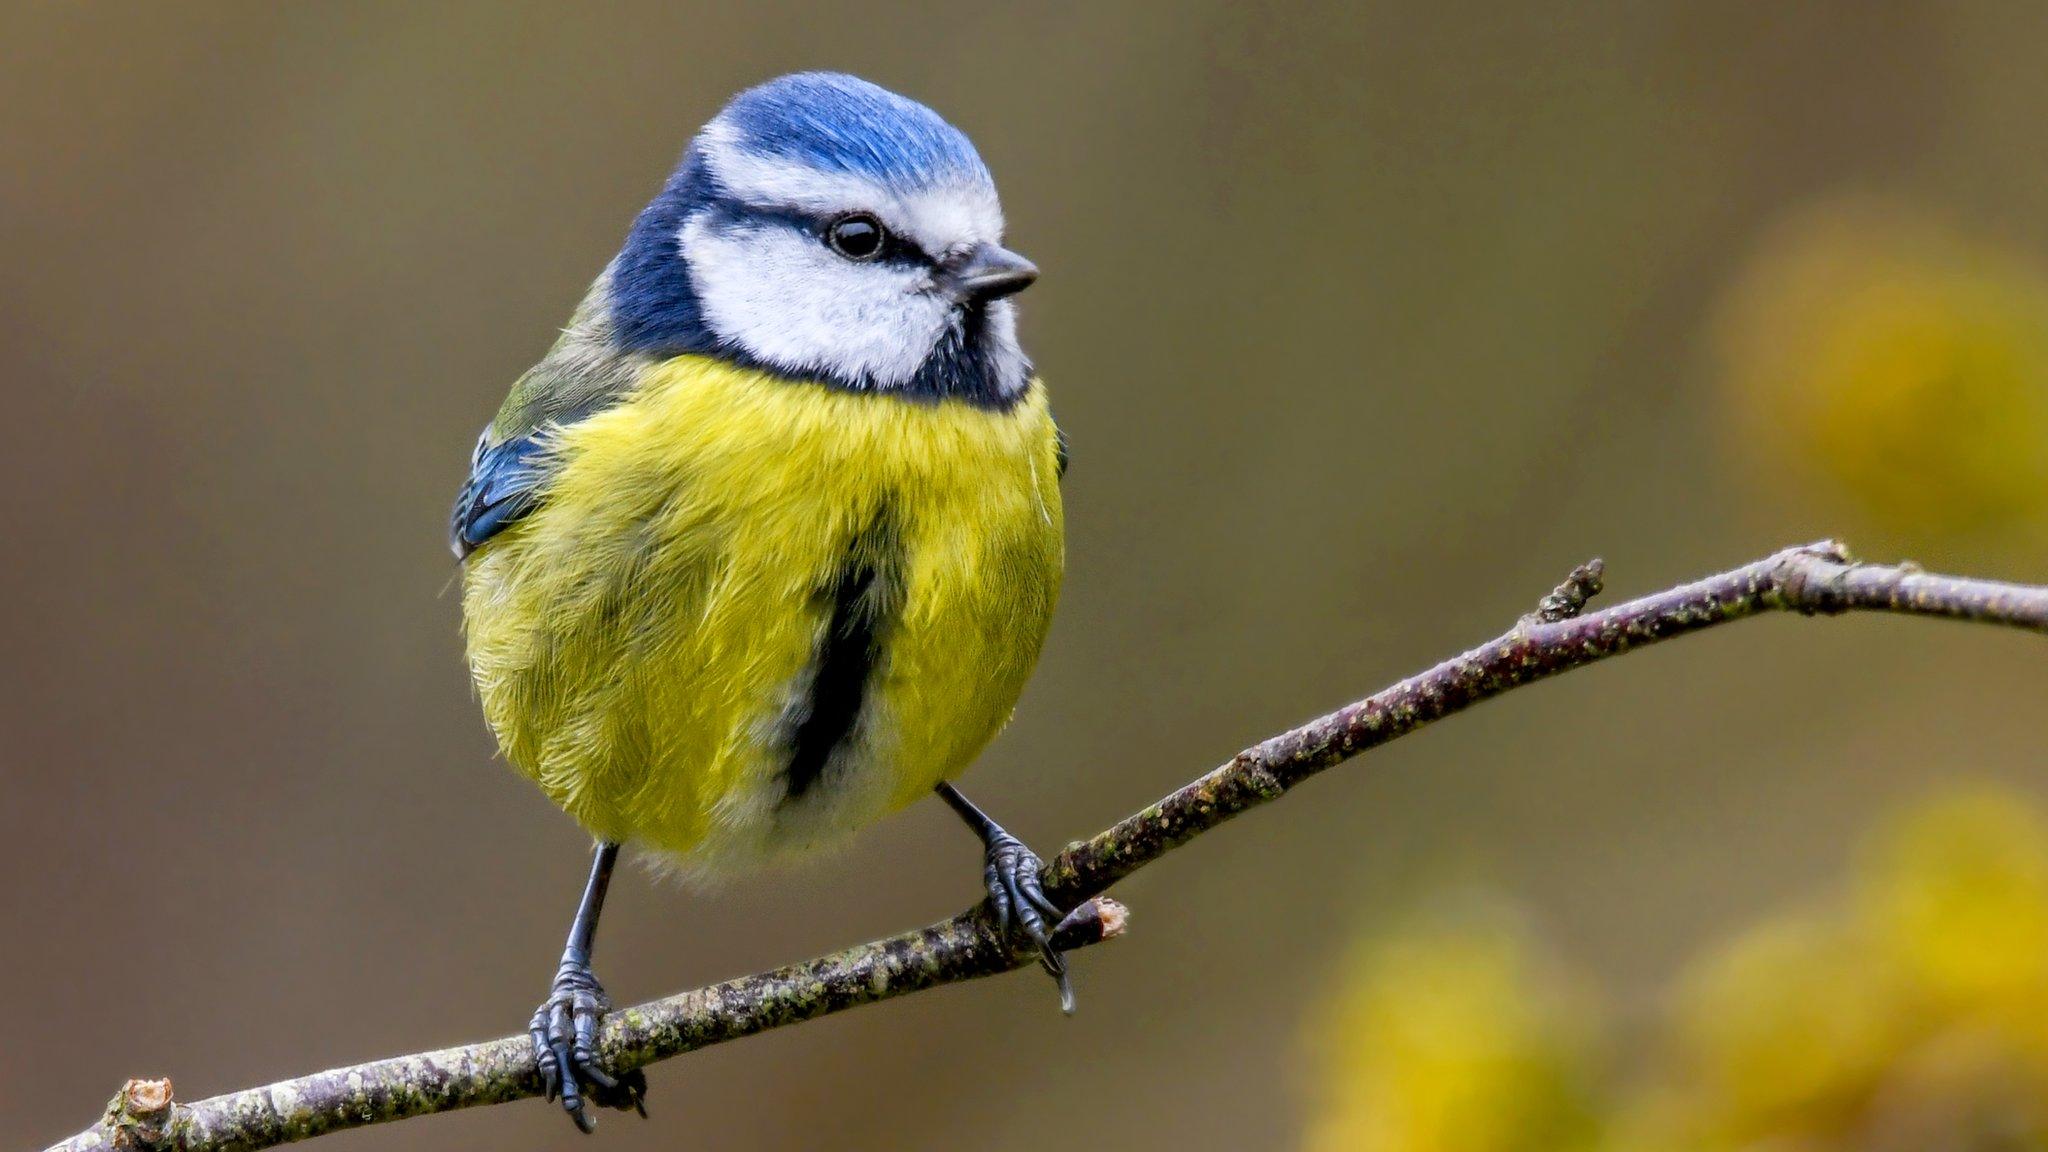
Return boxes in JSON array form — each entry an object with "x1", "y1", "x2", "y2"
[{"x1": 1307, "y1": 791, "x2": 2048, "y2": 1152}]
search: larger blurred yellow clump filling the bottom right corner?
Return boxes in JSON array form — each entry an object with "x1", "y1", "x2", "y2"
[{"x1": 1616, "y1": 791, "x2": 2048, "y2": 1152}]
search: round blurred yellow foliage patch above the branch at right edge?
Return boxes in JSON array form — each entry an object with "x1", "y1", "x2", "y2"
[{"x1": 1714, "y1": 197, "x2": 2048, "y2": 545}]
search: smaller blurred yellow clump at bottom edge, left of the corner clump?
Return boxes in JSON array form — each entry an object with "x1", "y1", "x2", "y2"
[{"x1": 1307, "y1": 908, "x2": 1597, "y2": 1152}]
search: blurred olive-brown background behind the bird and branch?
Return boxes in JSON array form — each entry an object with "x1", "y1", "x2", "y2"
[{"x1": 0, "y1": 0, "x2": 2048, "y2": 1150}]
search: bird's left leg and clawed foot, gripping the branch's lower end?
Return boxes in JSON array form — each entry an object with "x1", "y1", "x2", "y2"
[{"x1": 526, "y1": 840, "x2": 647, "y2": 1132}]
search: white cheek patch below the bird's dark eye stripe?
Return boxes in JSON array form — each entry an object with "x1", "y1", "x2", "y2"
[{"x1": 680, "y1": 215, "x2": 952, "y2": 387}]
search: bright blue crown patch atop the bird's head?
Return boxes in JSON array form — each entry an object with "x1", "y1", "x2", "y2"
[{"x1": 719, "y1": 72, "x2": 993, "y2": 189}]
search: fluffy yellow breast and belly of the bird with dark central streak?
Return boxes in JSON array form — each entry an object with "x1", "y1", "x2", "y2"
[{"x1": 463, "y1": 357, "x2": 1063, "y2": 871}]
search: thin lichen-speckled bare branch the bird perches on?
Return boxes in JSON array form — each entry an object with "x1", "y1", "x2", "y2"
[{"x1": 51, "y1": 541, "x2": 2048, "y2": 1152}]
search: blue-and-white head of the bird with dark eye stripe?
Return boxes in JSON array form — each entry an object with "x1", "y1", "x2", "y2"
[{"x1": 608, "y1": 72, "x2": 1038, "y2": 404}]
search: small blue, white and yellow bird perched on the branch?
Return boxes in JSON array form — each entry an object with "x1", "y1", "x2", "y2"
[{"x1": 451, "y1": 72, "x2": 1073, "y2": 1132}]
